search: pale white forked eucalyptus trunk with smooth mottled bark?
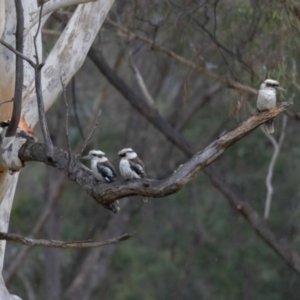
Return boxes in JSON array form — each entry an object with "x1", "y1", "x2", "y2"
[{"x1": 0, "y1": 0, "x2": 114, "y2": 300}]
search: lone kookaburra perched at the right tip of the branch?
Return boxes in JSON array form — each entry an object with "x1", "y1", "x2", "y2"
[{"x1": 256, "y1": 79, "x2": 284, "y2": 133}]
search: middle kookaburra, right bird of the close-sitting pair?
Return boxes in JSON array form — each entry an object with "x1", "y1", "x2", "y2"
[{"x1": 118, "y1": 148, "x2": 148, "y2": 202}]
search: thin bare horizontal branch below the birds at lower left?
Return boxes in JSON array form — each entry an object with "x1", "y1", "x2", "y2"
[{"x1": 0, "y1": 232, "x2": 132, "y2": 248}]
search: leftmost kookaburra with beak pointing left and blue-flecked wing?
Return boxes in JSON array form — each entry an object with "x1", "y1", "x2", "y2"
[{"x1": 82, "y1": 150, "x2": 117, "y2": 183}]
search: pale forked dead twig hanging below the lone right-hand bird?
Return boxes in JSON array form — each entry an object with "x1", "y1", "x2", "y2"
[{"x1": 263, "y1": 115, "x2": 287, "y2": 219}]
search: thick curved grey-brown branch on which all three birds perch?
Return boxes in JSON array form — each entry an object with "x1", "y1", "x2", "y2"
[{"x1": 19, "y1": 102, "x2": 290, "y2": 206}]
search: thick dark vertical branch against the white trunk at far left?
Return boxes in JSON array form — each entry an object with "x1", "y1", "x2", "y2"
[{"x1": 5, "y1": 0, "x2": 24, "y2": 137}]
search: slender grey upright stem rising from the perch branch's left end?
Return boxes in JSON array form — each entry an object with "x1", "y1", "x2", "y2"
[{"x1": 33, "y1": 2, "x2": 53, "y2": 159}]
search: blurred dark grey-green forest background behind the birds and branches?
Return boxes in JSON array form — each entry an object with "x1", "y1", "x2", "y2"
[{"x1": 4, "y1": 0, "x2": 300, "y2": 300}]
